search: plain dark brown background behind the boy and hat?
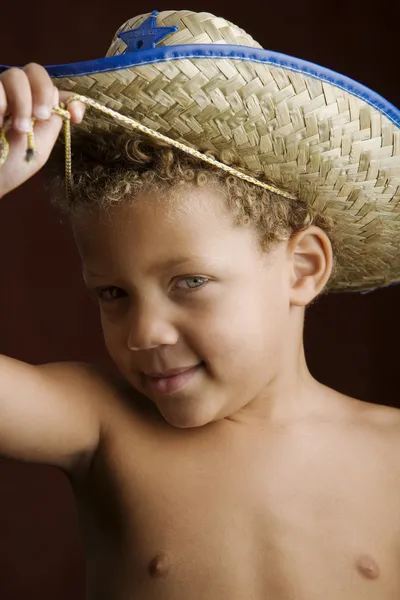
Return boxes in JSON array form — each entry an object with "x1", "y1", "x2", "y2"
[{"x1": 0, "y1": 0, "x2": 400, "y2": 600}]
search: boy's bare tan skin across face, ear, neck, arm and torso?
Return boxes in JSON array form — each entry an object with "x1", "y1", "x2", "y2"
[{"x1": 0, "y1": 63, "x2": 400, "y2": 600}]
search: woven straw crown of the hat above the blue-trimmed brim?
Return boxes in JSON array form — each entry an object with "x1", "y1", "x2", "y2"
[{"x1": 106, "y1": 10, "x2": 262, "y2": 57}]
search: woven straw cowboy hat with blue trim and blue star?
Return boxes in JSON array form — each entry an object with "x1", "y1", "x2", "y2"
[{"x1": 2, "y1": 10, "x2": 400, "y2": 291}]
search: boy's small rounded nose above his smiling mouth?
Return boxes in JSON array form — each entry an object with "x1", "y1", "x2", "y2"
[{"x1": 127, "y1": 303, "x2": 179, "y2": 350}]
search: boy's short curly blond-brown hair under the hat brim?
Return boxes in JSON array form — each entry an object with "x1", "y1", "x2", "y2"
[{"x1": 43, "y1": 126, "x2": 338, "y2": 278}]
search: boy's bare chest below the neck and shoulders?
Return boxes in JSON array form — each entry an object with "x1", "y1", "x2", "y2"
[{"x1": 70, "y1": 422, "x2": 400, "y2": 600}]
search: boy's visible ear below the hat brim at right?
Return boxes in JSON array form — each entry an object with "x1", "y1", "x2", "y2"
[{"x1": 287, "y1": 225, "x2": 333, "y2": 306}]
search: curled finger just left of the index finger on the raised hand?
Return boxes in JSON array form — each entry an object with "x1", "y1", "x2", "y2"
[{"x1": 2, "y1": 67, "x2": 32, "y2": 133}]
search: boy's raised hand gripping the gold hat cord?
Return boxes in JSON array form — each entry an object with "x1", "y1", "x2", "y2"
[{"x1": 0, "y1": 63, "x2": 86, "y2": 198}]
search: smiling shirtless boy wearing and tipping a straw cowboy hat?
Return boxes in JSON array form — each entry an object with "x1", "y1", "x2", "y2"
[{"x1": 0, "y1": 11, "x2": 400, "y2": 600}]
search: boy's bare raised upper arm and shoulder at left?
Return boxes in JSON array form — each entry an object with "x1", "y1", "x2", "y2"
[{"x1": 0, "y1": 355, "x2": 134, "y2": 473}]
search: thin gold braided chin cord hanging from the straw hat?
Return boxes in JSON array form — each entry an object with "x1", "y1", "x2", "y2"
[{"x1": 0, "y1": 94, "x2": 296, "y2": 200}]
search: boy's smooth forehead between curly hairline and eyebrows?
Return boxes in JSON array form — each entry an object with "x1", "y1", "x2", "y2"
[{"x1": 73, "y1": 188, "x2": 260, "y2": 268}]
